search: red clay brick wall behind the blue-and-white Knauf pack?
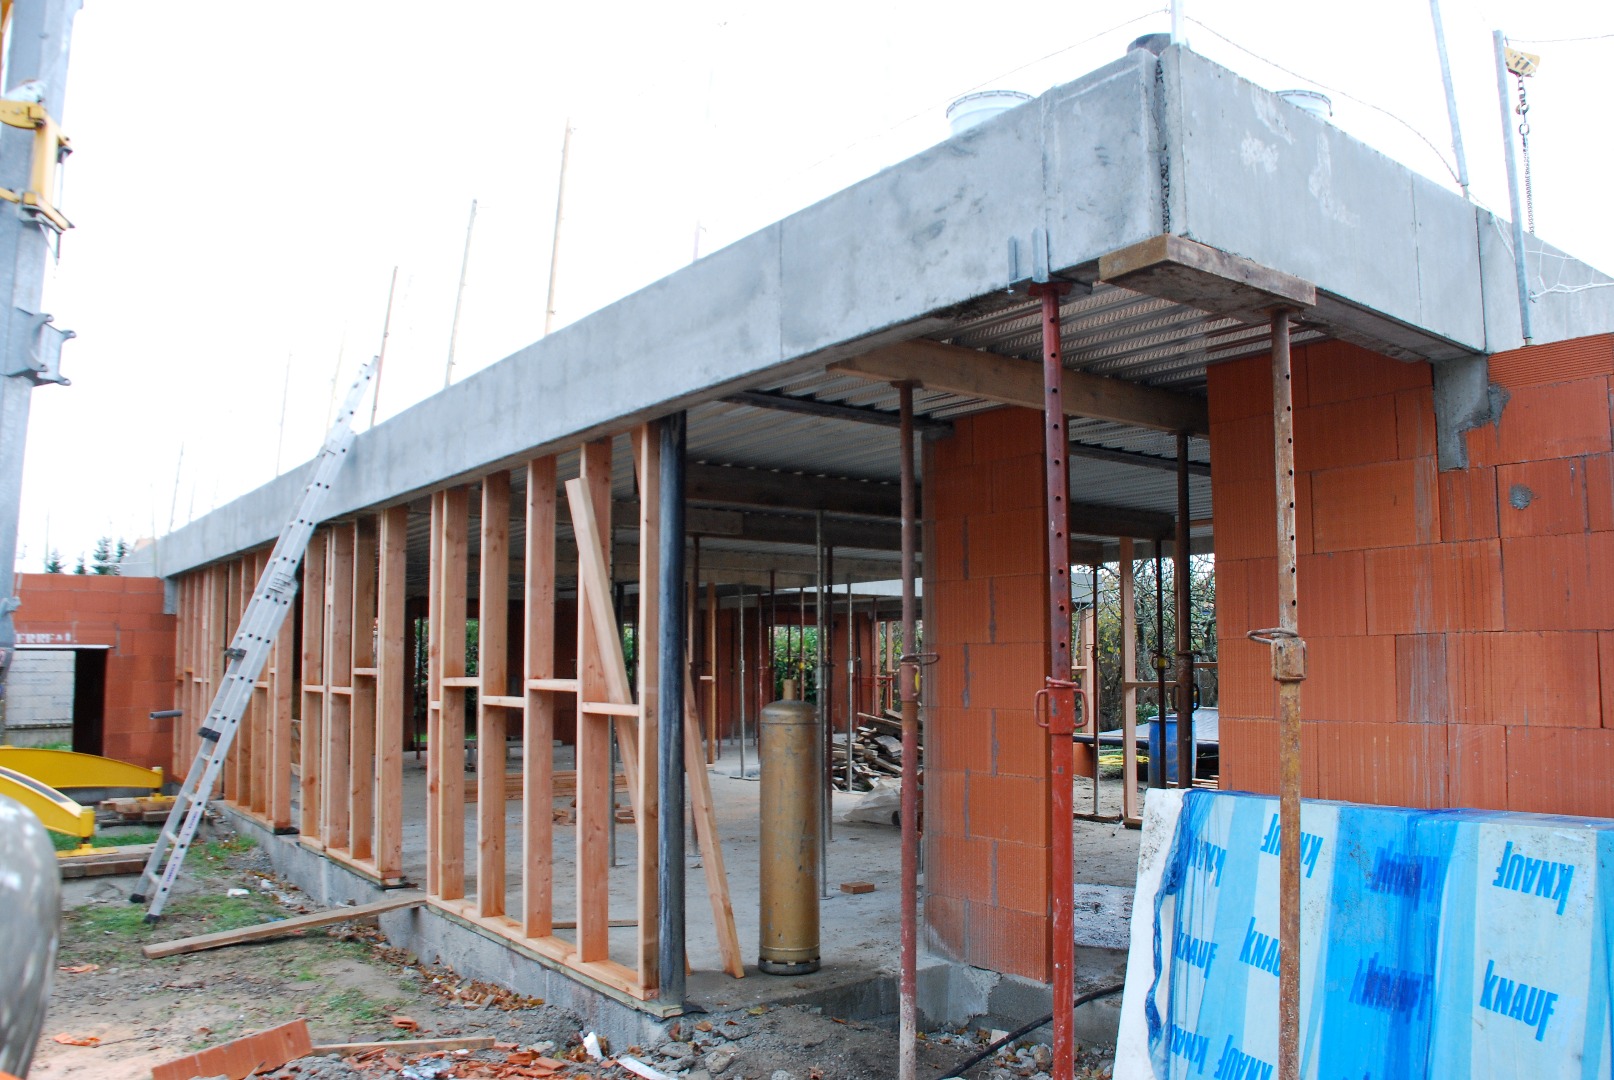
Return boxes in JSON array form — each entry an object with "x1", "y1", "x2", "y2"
[{"x1": 1209, "y1": 336, "x2": 1614, "y2": 817}]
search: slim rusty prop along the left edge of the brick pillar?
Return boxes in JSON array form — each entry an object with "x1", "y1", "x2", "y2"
[{"x1": 897, "y1": 383, "x2": 918, "y2": 1080}]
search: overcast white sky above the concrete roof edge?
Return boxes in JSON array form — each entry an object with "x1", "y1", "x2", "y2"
[{"x1": 18, "y1": 0, "x2": 1614, "y2": 571}]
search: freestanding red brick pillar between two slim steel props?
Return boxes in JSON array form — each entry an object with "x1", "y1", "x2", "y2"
[{"x1": 925, "y1": 408, "x2": 1051, "y2": 982}]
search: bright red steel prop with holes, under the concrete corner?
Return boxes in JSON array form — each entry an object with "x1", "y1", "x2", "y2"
[{"x1": 1031, "y1": 277, "x2": 1077, "y2": 1080}]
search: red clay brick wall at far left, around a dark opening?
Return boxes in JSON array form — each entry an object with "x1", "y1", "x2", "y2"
[{"x1": 16, "y1": 573, "x2": 174, "y2": 768}]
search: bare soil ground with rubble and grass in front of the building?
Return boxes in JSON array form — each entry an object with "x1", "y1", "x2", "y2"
[{"x1": 29, "y1": 820, "x2": 1110, "y2": 1080}]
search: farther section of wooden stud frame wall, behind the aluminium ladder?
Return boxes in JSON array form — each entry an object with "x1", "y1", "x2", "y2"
[{"x1": 173, "y1": 507, "x2": 408, "y2": 886}]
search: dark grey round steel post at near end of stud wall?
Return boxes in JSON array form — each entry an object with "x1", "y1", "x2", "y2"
[{"x1": 655, "y1": 413, "x2": 686, "y2": 1006}]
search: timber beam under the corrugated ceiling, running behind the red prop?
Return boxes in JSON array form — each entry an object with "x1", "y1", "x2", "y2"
[{"x1": 831, "y1": 339, "x2": 1211, "y2": 434}]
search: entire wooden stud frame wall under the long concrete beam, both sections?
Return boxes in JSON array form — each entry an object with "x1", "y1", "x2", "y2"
[{"x1": 174, "y1": 425, "x2": 744, "y2": 999}]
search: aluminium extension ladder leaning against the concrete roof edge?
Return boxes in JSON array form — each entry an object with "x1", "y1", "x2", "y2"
[{"x1": 129, "y1": 360, "x2": 376, "y2": 922}]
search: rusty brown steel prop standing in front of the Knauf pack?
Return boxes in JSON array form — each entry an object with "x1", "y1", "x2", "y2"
[{"x1": 1249, "y1": 308, "x2": 1306, "y2": 1080}]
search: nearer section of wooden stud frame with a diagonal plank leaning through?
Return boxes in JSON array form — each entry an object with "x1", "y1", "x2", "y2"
[{"x1": 426, "y1": 426, "x2": 744, "y2": 999}]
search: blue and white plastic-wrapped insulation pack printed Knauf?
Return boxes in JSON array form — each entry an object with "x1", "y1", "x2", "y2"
[{"x1": 1115, "y1": 791, "x2": 1614, "y2": 1080}]
